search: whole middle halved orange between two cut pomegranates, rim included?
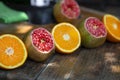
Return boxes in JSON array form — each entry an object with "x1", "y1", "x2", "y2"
[{"x1": 52, "y1": 23, "x2": 81, "y2": 53}]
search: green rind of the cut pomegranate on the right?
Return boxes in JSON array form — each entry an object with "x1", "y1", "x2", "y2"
[{"x1": 78, "y1": 20, "x2": 106, "y2": 48}]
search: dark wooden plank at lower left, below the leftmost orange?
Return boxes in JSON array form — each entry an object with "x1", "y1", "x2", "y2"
[{"x1": 0, "y1": 57, "x2": 53, "y2": 80}]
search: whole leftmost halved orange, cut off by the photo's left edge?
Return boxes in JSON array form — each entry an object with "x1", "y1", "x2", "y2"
[{"x1": 0, "y1": 34, "x2": 27, "y2": 69}]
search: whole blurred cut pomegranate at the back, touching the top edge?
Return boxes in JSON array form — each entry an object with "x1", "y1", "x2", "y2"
[{"x1": 54, "y1": 0, "x2": 80, "y2": 22}]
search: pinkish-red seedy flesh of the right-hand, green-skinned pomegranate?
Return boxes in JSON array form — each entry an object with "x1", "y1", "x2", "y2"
[{"x1": 84, "y1": 17, "x2": 107, "y2": 38}]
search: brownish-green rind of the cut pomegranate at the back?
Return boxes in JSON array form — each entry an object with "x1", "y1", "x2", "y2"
[{"x1": 53, "y1": 0, "x2": 79, "y2": 23}]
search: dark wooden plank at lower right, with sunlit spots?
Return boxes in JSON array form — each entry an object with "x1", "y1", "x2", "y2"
[{"x1": 69, "y1": 42, "x2": 120, "y2": 80}]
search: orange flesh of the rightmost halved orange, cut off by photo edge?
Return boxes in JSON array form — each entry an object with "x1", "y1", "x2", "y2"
[{"x1": 106, "y1": 17, "x2": 120, "y2": 37}]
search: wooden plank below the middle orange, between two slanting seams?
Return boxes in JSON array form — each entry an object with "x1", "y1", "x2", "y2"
[{"x1": 37, "y1": 49, "x2": 80, "y2": 80}]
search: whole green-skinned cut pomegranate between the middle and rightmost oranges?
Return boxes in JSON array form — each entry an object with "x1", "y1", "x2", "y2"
[{"x1": 79, "y1": 17, "x2": 107, "y2": 48}]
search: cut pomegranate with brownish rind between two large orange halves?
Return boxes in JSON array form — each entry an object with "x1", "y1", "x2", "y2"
[{"x1": 25, "y1": 28, "x2": 54, "y2": 61}]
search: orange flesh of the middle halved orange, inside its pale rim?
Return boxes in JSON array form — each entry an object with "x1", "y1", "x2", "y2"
[{"x1": 54, "y1": 25, "x2": 79, "y2": 50}]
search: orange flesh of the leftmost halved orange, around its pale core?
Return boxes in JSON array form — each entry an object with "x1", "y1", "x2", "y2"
[{"x1": 0, "y1": 37, "x2": 24, "y2": 66}]
